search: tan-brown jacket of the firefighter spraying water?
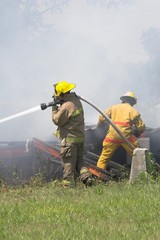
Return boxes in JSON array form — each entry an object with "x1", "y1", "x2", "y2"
[{"x1": 52, "y1": 92, "x2": 85, "y2": 143}]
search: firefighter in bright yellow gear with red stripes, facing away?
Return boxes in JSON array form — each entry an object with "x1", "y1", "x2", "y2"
[{"x1": 97, "y1": 92, "x2": 145, "y2": 169}]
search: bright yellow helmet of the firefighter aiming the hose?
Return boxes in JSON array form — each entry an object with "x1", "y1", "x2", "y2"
[{"x1": 53, "y1": 81, "x2": 76, "y2": 97}]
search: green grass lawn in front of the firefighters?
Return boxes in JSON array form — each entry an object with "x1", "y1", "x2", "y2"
[{"x1": 0, "y1": 178, "x2": 160, "y2": 240}]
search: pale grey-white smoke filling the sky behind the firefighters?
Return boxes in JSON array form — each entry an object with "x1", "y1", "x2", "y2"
[{"x1": 0, "y1": 0, "x2": 160, "y2": 141}]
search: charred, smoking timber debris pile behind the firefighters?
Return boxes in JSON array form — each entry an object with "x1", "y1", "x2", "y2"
[{"x1": 0, "y1": 125, "x2": 160, "y2": 184}]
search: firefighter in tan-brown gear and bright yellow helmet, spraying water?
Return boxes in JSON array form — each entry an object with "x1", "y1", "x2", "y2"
[{"x1": 52, "y1": 81, "x2": 92, "y2": 186}]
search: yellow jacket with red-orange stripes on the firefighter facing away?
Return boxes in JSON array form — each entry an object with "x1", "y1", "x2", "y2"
[{"x1": 99, "y1": 103, "x2": 145, "y2": 141}]
